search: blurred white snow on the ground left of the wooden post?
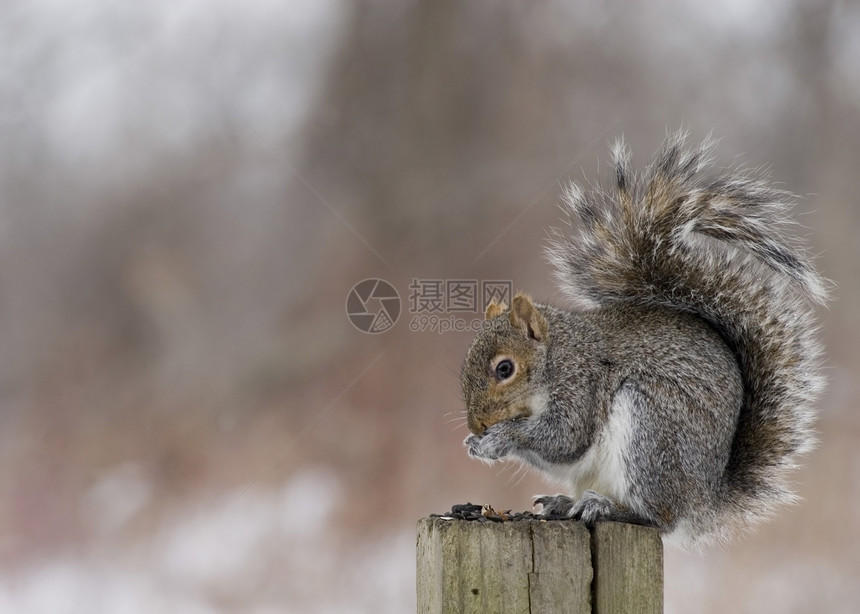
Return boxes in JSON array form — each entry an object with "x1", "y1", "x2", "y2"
[{"x1": 0, "y1": 466, "x2": 415, "y2": 614}]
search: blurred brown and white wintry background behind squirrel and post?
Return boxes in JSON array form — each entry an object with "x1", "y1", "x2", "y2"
[{"x1": 0, "y1": 0, "x2": 860, "y2": 614}]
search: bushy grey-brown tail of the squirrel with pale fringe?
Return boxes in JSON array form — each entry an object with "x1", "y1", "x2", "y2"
[{"x1": 548, "y1": 133, "x2": 827, "y2": 540}]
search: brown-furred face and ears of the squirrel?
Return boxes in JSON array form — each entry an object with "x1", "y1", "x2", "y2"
[{"x1": 463, "y1": 294, "x2": 547, "y2": 435}]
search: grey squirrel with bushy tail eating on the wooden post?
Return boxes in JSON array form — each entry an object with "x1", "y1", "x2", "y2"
[{"x1": 461, "y1": 131, "x2": 829, "y2": 547}]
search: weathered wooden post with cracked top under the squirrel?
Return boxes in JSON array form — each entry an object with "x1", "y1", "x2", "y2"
[{"x1": 417, "y1": 518, "x2": 663, "y2": 614}]
